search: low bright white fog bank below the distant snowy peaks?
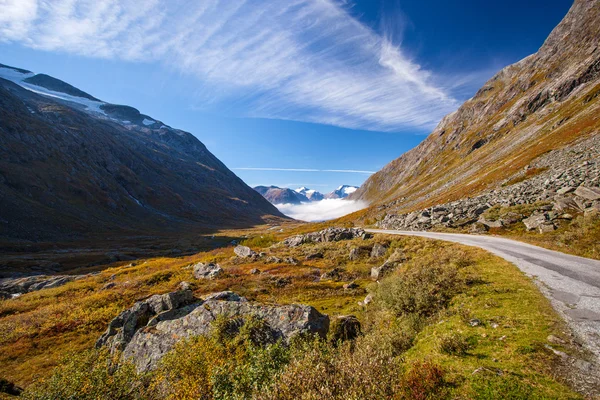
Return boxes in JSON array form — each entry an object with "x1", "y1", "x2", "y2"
[{"x1": 276, "y1": 199, "x2": 368, "y2": 222}]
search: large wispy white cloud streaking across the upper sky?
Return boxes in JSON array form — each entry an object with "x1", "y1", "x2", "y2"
[{"x1": 0, "y1": 0, "x2": 458, "y2": 131}]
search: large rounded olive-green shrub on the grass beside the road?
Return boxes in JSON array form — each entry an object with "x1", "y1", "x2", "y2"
[{"x1": 378, "y1": 265, "x2": 464, "y2": 316}]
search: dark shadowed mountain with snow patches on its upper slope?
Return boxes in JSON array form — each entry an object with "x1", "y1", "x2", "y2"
[{"x1": 0, "y1": 65, "x2": 283, "y2": 241}]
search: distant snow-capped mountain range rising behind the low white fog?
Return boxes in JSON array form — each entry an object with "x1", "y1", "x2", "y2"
[{"x1": 254, "y1": 185, "x2": 358, "y2": 204}]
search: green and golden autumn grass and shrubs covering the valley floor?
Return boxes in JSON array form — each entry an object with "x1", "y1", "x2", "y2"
[{"x1": 0, "y1": 235, "x2": 579, "y2": 399}]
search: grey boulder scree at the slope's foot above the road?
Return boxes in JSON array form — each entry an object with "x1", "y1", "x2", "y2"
[{"x1": 378, "y1": 135, "x2": 600, "y2": 233}]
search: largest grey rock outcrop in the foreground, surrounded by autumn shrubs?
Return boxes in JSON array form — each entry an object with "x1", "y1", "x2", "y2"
[{"x1": 96, "y1": 290, "x2": 329, "y2": 371}]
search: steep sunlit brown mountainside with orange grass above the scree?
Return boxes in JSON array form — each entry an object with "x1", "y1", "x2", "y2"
[{"x1": 351, "y1": 0, "x2": 600, "y2": 210}]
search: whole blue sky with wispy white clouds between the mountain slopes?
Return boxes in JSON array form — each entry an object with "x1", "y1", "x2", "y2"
[{"x1": 0, "y1": 0, "x2": 571, "y2": 192}]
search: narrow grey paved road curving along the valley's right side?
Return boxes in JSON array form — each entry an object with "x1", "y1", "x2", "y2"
[{"x1": 366, "y1": 229, "x2": 600, "y2": 361}]
